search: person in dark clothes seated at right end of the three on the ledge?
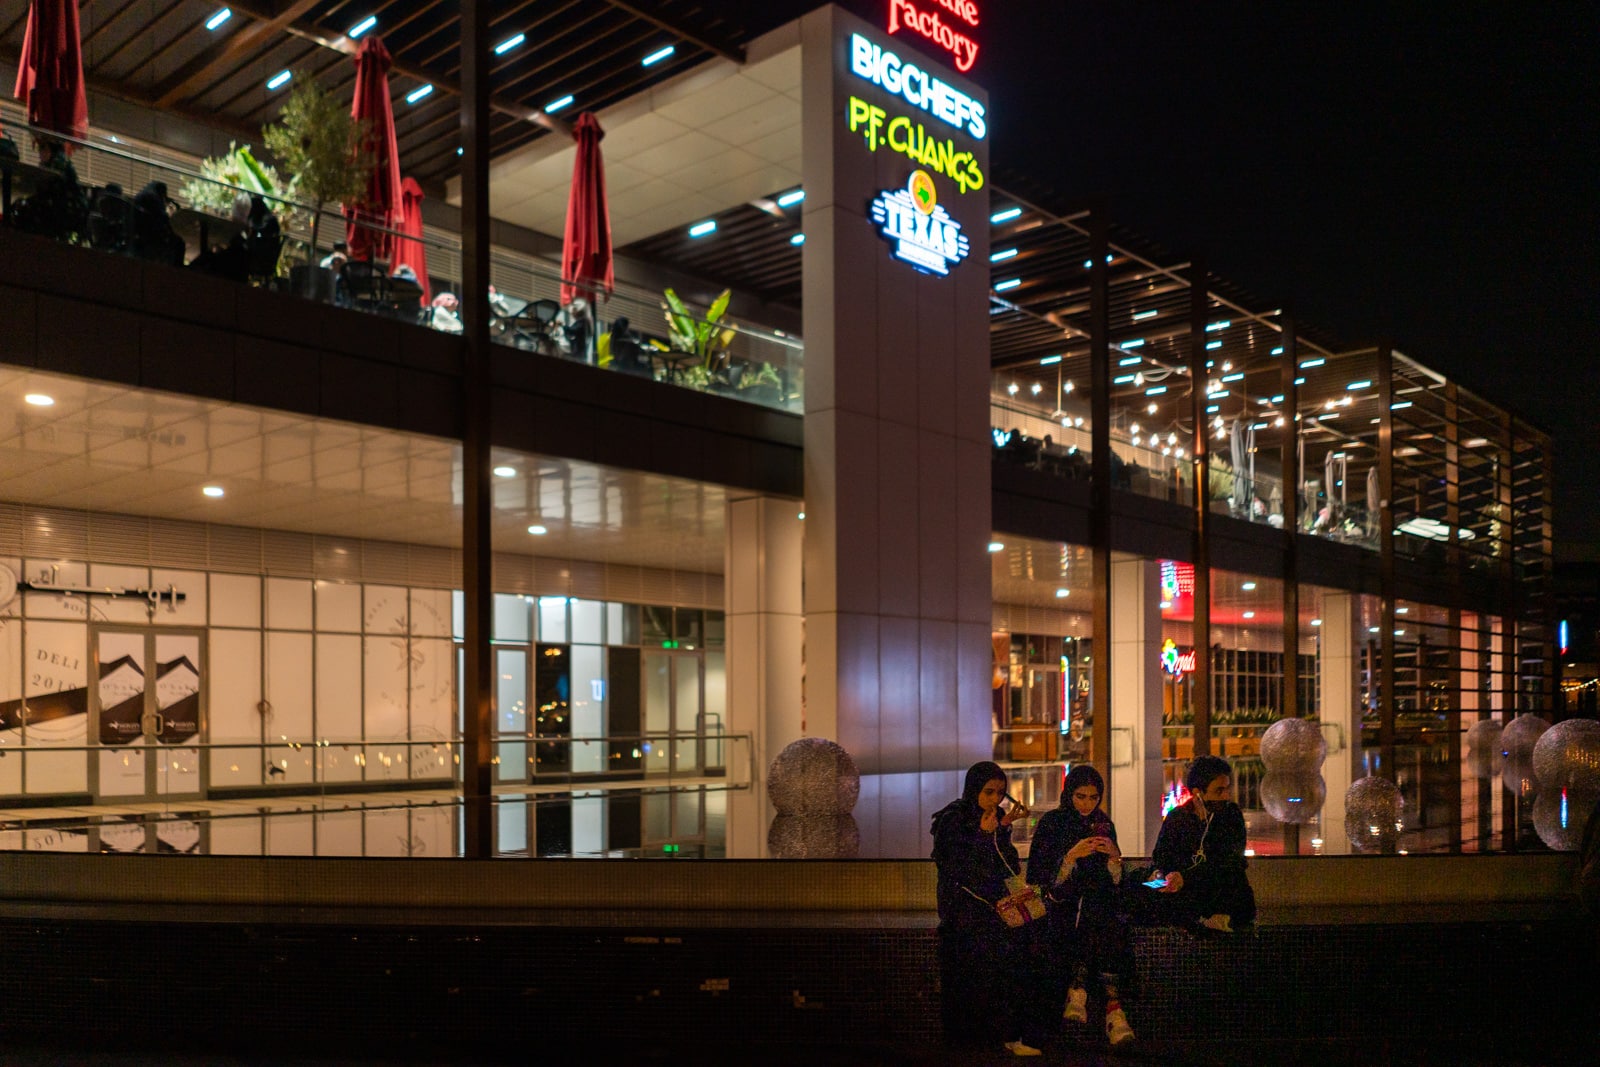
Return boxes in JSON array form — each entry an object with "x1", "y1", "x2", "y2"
[{"x1": 1150, "y1": 755, "x2": 1256, "y2": 933}]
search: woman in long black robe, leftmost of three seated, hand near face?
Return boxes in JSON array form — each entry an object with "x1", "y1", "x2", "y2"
[{"x1": 930, "y1": 760, "x2": 1043, "y2": 1056}]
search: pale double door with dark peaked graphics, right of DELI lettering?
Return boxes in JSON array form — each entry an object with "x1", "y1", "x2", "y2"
[{"x1": 93, "y1": 627, "x2": 205, "y2": 800}]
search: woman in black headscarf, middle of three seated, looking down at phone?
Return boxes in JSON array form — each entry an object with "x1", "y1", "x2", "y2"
[{"x1": 1027, "y1": 763, "x2": 1133, "y2": 1045}]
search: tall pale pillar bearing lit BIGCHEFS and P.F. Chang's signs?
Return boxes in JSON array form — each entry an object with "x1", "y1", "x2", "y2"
[{"x1": 800, "y1": 6, "x2": 992, "y2": 777}]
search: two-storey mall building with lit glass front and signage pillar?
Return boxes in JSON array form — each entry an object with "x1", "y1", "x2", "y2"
[{"x1": 0, "y1": 8, "x2": 1558, "y2": 856}]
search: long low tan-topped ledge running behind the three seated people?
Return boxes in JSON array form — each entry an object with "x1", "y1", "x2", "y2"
[{"x1": 0, "y1": 853, "x2": 1576, "y2": 925}]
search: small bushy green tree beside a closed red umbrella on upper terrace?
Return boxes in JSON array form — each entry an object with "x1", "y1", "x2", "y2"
[{"x1": 261, "y1": 78, "x2": 373, "y2": 280}]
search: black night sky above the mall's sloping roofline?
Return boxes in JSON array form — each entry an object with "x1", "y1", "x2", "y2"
[{"x1": 704, "y1": 0, "x2": 1600, "y2": 558}]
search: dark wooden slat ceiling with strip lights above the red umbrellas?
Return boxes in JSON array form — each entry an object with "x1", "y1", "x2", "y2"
[{"x1": 0, "y1": 0, "x2": 749, "y2": 192}]
